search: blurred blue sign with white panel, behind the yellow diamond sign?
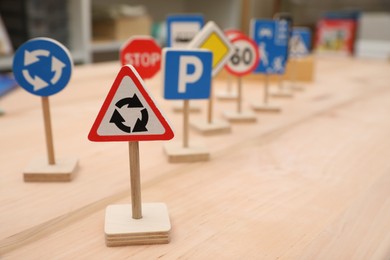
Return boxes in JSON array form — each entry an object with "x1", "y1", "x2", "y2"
[{"x1": 167, "y1": 14, "x2": 204, "y2": 48}]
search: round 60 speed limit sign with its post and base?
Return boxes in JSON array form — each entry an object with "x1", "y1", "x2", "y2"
[{"x1": 224, "y1": 34, "x2": 260, "y2": 122}]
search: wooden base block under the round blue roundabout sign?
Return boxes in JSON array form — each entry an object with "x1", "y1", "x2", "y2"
[{"x1": 23, "y1": 157, "x2": 78, "y2": 182}]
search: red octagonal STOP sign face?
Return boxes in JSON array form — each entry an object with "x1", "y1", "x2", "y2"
[{"x1": 120, "y1": 36, "x2": 161, "y2": 79}]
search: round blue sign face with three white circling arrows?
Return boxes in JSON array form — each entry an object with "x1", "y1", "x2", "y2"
[{"x1": 12, "y1": 37, "x2": 73, "y2": 97}]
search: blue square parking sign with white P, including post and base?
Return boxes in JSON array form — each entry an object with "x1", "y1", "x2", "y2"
[{"x1": 163, "y1": 48, "x2": 212, "y2": 162}]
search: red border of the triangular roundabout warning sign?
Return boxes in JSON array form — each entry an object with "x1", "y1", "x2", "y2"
[{"x1": 88, "y1": 65, "x2": 174, "y2": 142}]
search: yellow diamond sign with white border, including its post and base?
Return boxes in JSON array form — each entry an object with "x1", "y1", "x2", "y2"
[{"x1": 188, "y1": 21, "x2": 234, "y2": 134}]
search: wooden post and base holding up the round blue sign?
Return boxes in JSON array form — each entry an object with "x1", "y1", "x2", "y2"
[{"x1": 23, "y1": 97, "x2": 78, "y2": 182}]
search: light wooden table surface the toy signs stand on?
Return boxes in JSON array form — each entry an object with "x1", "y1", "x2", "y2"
[{"x1": 0, "y1": 57, "x2": 390, "y2": 260}]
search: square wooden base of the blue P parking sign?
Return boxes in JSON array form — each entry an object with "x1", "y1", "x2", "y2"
[{"x1": 164, "y1": 142, "x2": 210, "y2": 163}]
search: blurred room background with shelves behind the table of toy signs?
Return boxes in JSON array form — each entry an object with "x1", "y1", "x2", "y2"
[{"x1": 0, "y1": 0, "x2": 390, "y2": 71}]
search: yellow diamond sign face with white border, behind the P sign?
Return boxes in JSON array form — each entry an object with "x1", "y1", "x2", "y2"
[{"x1": 188, "y1": 21, "x2": 234, "y2": 77}]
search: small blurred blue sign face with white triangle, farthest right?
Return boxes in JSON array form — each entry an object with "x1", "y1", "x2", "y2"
[{"x1": 289, "y1": 27, "x2": 311, "y2": 58}]
